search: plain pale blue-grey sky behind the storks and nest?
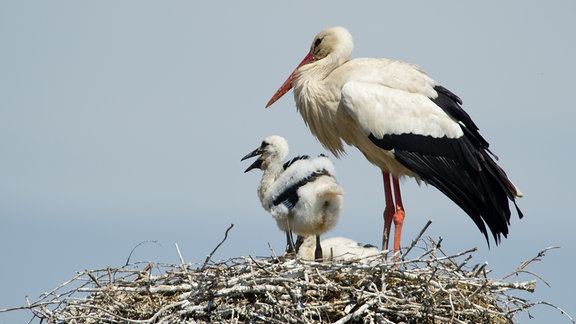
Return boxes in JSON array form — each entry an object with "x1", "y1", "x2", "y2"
[{"x1": 0, "y1": 0, "x2": 576, "y2": 323}]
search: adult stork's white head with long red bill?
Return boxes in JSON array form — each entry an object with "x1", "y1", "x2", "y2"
[{"x1": 266, "y1": 27, "x2": 354, "y2": 108}]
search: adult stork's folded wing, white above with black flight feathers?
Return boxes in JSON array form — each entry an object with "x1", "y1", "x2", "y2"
[{"x1": 341, "y1": 81, "x2": 522, "y2": 243}]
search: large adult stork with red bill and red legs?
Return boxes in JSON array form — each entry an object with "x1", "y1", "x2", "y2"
[{"x1": 266, "y1": 27, "x2": 522, "y2": 253}]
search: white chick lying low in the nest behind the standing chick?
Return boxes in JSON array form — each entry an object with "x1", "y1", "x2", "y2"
[{"x1": 296, "y1": 236, "x2": 380, "y2": 262}]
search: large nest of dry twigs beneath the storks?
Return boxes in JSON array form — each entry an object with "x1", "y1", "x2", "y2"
[{"x1": 3, "y1": 225, "x2": 568, "y2": 323}]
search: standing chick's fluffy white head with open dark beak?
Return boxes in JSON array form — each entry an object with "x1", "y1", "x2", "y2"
[{"x1": 241, "y1": 135, "x2": 289, "y2": 172}]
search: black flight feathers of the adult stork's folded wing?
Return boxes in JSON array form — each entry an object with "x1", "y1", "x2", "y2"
[{"x1": 369, "y1": 86, "x2": 522, "y2": 244}]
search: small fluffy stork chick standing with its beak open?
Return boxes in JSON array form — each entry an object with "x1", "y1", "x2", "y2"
[{"x1": 242, "y1": 135, "x2": 344, "y2": 261}]
